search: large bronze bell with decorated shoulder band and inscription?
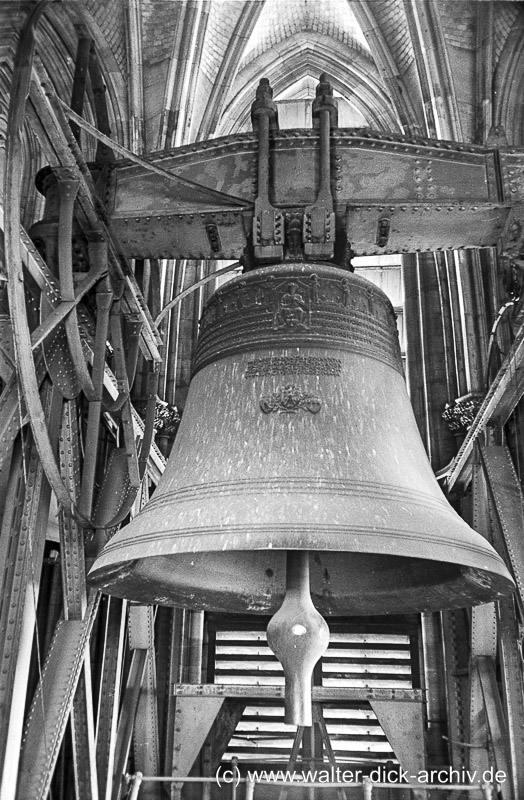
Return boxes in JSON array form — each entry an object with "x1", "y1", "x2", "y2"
[{"x1": 91, "y1": 262, "x2": 512, "y2": 615}]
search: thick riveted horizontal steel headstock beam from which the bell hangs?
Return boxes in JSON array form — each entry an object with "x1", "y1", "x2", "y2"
[{"x1": 93, "y1": 129, "x2": 524, "y2": 258}]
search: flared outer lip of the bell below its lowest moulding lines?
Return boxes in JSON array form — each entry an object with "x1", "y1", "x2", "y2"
[{"x1": 89, "y1": 518, "x2": 514, "y2": 600}]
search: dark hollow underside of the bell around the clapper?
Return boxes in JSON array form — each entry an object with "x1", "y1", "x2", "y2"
[{"x1": 91, "y1": 550, "x2": 512, "y2": 616}]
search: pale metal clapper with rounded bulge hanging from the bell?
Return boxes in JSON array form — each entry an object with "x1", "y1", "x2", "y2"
[{"x1": 267, "y1": 550, "x2": 329, "y2": 727}]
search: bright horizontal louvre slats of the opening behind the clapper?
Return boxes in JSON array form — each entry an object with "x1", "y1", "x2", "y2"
[{"x1": 214, "y1": 630, "x2": 413, "y2": 767}]
